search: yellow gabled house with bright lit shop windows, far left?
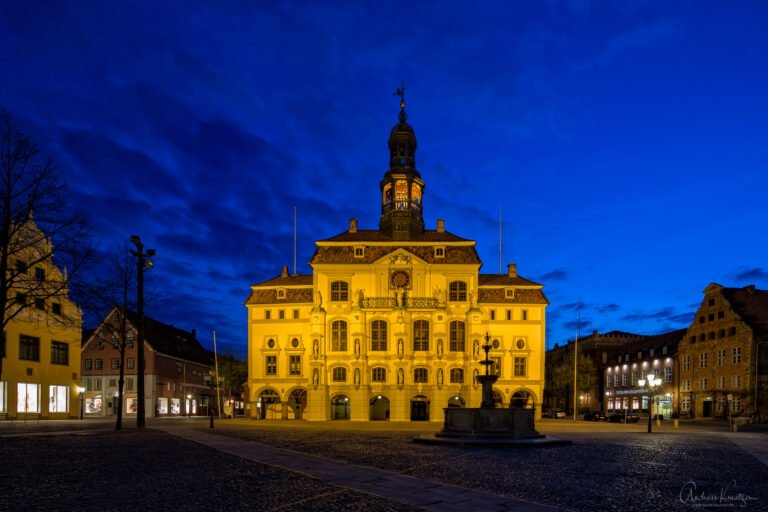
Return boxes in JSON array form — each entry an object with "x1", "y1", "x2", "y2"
[{"x1": 0, "y1": 221, "x2": 82, "y2": 420}]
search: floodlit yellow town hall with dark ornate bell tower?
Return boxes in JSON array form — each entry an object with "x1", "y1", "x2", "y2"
[{"x1": 246, "y1": 98, "x2": 547, "y2": 422}]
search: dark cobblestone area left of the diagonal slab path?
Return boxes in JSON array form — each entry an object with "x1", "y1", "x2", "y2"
[{"x1": 0, "y1": 430, "x2": 419, "y2": 512}]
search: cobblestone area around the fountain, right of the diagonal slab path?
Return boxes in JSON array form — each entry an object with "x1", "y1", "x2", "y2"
[{"x1": 210, "y1": 426, "x2": 768, "y2": 511}]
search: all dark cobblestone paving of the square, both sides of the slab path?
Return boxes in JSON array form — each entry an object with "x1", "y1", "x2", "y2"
[{"x1": 0, "y1": 419, "x2": 768, "y2": 512}]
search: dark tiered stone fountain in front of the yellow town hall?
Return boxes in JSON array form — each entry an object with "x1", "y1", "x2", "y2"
[{"x1": 414, "y1": 333, "x2": 570, "y2": 446}]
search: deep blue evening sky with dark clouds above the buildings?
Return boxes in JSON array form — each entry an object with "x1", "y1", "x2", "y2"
[{"x1": 0, "y1": 1, "x2": 768, "y2": 349}]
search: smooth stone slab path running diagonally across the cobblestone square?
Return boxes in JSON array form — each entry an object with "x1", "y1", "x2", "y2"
[{"x1": 168, "y1": 429, "x2": 562, "y2": 512}]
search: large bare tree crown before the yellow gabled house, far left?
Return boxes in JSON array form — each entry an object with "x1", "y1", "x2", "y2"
[{"x1": 0, "y1": 110, "x2": 93, "y2": 384}]
